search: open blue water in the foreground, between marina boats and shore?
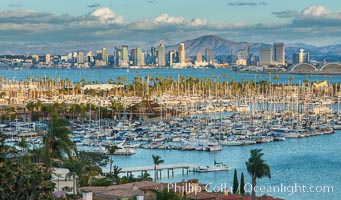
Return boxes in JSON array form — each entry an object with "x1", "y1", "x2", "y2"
[{"x1": 113, "y1": 131, "x2": 341, "y2": 200}]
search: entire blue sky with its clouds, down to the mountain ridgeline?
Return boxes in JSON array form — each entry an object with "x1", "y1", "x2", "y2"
[{"x1": 0, "y1": 0, "x2": 341, "y2": 49}]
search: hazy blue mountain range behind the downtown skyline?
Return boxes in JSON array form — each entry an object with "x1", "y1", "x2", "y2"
[{"x1": 0, "y1": 35, "x2": 341, "y2": 60}]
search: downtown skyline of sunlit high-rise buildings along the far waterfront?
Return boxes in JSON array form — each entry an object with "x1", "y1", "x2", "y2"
[{"x1": 0, "y1": 42, "x2": 310, "y2": 68}]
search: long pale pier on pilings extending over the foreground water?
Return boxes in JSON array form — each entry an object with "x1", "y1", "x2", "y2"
[{"x1": 116, "y1": 164, "x2": 198, "y2": 178}]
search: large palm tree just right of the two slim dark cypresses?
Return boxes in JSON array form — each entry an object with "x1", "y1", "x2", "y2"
[{"x1": 245, "y1": 149, "x2": 271, "y2": 200}]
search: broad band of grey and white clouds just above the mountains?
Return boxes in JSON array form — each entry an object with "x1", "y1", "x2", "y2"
[{"x1": 0, "y1": 6, "x2": 341, "y2": 48}]
